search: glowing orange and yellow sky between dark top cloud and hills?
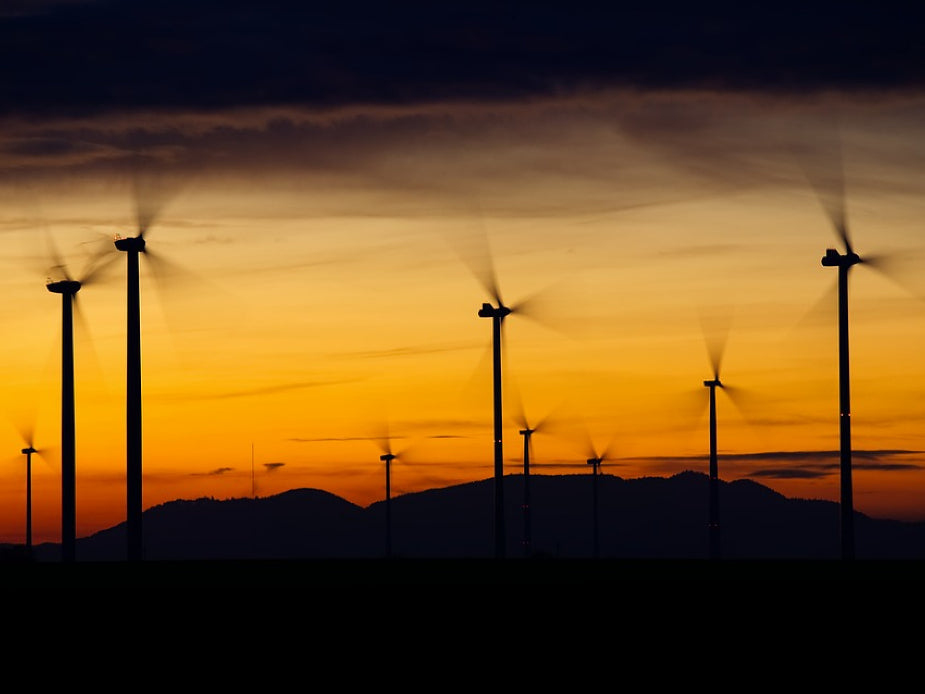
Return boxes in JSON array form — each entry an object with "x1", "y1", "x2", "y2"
[{"x1": 0, "y1": 3, "x2": 925, "y2": 542}]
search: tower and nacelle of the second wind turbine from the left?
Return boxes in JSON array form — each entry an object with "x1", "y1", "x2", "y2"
[{"x1": 45, "y1": 280, "x2": 80, "y2": 562}]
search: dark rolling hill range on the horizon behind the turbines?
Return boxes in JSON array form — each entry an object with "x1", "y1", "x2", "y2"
[{"x1": 8, "y1": 472, "x2": 925, "y2": 565}]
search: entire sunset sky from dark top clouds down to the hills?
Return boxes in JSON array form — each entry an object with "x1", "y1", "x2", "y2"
[{"x1": 0, "y1": 0, "x2": 925, "y2": 542}]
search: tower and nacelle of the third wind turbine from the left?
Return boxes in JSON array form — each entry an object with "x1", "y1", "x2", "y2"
[{"x1": 116, "y1": 236, "x2": 145, "y2": 561}]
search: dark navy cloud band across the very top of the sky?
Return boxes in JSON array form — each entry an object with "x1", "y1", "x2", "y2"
[{"x1": 0, "y1": 0, "x2": 925, "y2": 116}]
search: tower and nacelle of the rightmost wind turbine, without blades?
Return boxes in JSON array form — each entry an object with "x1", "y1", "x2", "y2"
[{"x1": 822, "y1": 248, "x2": 861, "y2": 559}]
